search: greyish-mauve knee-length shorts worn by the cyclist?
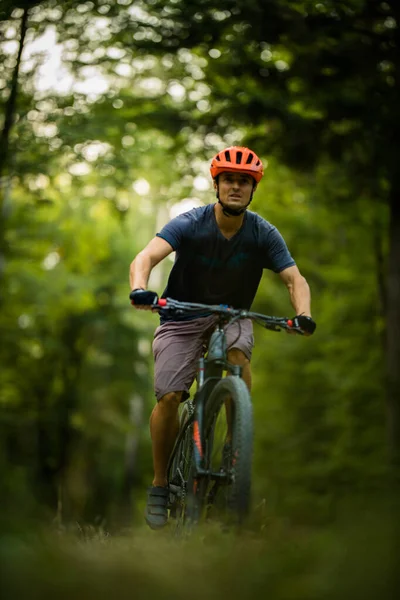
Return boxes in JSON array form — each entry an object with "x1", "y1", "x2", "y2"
[{"x1": 153, "y1": 315, "x2": 254, "y2": 400}]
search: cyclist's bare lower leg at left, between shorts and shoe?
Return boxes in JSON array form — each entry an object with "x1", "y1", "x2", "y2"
[{"x1": 150, "y1": 392, "x2": 183, "y2": 487}]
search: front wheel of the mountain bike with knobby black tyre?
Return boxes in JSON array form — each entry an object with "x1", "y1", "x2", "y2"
[{"x1": 203, "y1": 376, "x2": 253, "y2": 524}]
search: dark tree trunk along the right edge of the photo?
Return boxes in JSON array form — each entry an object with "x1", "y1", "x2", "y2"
[{"x1": 386, "y1": 185, "x2": 400, "y2": 467}]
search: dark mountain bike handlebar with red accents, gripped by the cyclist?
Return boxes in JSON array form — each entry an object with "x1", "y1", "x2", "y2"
[{"x1": 152, "y1": 298, "x2": 304, "y2": 335}]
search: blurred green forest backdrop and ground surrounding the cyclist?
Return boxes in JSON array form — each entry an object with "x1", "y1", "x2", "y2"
[{"x1": 0, "y1": 0, "x2": 400, "y2": 598}]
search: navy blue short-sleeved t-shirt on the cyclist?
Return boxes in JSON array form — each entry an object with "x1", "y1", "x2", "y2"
[{"x1": 157, "y1": 204, "x2": 296, "y2": 321}]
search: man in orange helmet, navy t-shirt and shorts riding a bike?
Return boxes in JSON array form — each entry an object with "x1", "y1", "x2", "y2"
[{"x1": 130, "y1": 146, "x2": 315, "y2": 529}]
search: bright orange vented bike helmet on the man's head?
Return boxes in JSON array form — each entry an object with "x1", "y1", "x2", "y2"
[{"x1": 210, "y1": 146, "x2": 264, "y2": 183}]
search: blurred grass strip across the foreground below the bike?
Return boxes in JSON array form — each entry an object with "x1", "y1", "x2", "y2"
[{"x1": 0, "y1": 502, "x2": 399, "y2": 600}]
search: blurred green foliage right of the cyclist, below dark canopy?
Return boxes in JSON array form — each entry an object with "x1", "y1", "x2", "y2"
[{"x1": 253, "y1": 159, "x2": 387, "y2": 519}]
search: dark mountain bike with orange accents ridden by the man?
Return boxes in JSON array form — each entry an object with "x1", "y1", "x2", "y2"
[{"x1": 150, "y1": 298, "x2": 303, "y2": 529}]
